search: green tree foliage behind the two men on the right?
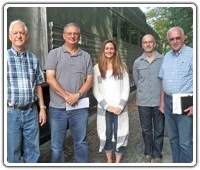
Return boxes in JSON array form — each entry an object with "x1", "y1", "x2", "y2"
[{"x1": 145, "y1": 7, "x2": 193, "y2": 53}]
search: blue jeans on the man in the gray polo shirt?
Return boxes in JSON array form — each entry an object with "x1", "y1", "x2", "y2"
[{"x1": 49, "y1": 107, "x2": 89, "y2": 163}]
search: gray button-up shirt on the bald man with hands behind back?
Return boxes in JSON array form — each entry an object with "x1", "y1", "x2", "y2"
[{"x1": 133, "y1": 52, "x2": 163, "y2": 107}]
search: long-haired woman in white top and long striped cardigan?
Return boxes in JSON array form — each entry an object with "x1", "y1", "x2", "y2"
[{"x1": 93, "y1": 39, "x2": 130, "y2": 163}]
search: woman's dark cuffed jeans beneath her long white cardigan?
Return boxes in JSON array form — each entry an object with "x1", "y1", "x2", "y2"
[{"x1": 105, "y1": 111, "x2": 125, "y2": 155}]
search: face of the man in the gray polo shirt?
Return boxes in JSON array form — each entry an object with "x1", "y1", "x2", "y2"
[{"x1": 63, "y1": 25, "x2": 80, "y2": 45}]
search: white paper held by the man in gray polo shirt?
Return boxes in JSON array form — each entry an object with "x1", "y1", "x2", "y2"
[{"x1": 66, "y1": 97, "x2": 90, "y2": 111}]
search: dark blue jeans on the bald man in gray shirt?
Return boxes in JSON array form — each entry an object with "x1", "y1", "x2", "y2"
[{"x1": 138, "y1": 106, "x2": 165, "y2": 158}]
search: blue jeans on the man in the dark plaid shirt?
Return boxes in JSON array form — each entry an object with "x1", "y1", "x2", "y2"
[{"x1": 7, "y1": 106, "x2": 40, "y2": 163}]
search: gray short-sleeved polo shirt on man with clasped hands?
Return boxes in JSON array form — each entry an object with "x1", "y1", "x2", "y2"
[{"x1": 45, "y1": 46, "x2": 93, "y2": 108}]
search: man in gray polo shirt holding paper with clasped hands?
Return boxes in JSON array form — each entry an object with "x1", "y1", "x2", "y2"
[{"x1": 45, "y1": 23, "x2": 93, "y2": 163}]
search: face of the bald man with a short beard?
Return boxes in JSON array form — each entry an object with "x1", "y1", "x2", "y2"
[{"x1": 142, "y1": 35, "x2": 156, "y2": 53}]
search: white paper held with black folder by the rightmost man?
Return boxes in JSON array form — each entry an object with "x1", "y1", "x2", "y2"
[{"x1": 172, "y1": 93, "x2": 193, "y2": 114}]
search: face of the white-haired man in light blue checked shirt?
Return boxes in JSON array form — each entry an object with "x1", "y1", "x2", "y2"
[{"x1": 168, "y1": 29, "x2": 185, "y2": 52}]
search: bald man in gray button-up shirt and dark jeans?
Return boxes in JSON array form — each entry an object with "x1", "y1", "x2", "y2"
[{"x1": 133, "y1": 34, "x2": 164, "y2": 163}]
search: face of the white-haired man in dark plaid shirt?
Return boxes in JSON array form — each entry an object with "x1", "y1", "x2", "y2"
[{"x1": 9, "y1": 23, "x2": 28, "y2": 51}]
